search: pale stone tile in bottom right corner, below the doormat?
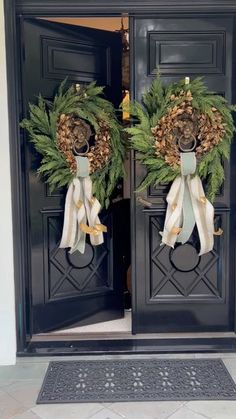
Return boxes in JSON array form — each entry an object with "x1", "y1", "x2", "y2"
[{"x1": 187, "y1": 400, "x2": 236, "y2": 419}]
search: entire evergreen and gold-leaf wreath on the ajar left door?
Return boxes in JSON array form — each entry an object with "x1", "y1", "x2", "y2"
[{"x1": 21, "y1": 80, "x2": 125, "y2": 208}]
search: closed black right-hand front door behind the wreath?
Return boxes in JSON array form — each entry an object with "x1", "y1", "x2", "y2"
[{"x1": 133, "y1": 16, "x2": 234, "y2": 333}]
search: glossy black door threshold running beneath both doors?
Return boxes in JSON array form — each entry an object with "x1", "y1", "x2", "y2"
[{"x1": 20, "y1": 332, "x2": 236, "y2": 356}]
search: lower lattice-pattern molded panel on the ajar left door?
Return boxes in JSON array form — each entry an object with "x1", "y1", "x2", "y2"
[{"x1": 41, "y1": 209, "x2": 112, "y2": 302}]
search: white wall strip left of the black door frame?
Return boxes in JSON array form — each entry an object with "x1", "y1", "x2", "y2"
[{"x1": 0, "y1": 0, "x2": 16, "y2": 365}]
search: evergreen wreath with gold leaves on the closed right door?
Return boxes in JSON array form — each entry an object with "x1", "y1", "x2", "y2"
[{"x1": 126, "y1": 75, "x2": 236, "y2": 202}]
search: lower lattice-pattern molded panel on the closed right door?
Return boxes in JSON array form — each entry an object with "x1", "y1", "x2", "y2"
[{"x1": 147, "y1": 213, "x2": 228, "y2": 304}]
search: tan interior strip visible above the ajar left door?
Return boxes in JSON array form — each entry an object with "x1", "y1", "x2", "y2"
[{"x1": 42, "y1": 17, "x2": 128, "y2": 31}]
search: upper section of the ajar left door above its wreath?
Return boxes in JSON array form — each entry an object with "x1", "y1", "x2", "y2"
[{"x1": 22, "y1": 19, "x2": 122, "y2": 107}]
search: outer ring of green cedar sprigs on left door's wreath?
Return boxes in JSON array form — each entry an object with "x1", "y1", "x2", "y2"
[{"x1": 21, "y1": 80, "x2": 125, "y2": 208}]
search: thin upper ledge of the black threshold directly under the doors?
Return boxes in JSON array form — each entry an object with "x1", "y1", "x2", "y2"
[{"x1": 31, "y1": 332, "x2": 235, "y2": 342}]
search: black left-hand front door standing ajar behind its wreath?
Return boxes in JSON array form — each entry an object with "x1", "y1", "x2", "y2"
[{"x1": 21, "y1": 19, "x2": 123, "y2": 333}]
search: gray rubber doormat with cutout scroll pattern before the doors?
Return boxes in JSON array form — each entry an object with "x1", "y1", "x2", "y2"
[{"x1": 37, "y1": 358, "x2": 236, "y2": 404}]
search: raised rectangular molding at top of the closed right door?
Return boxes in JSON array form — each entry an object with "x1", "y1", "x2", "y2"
[{"x1": 148, "y1": 31, "x2": 225, "y2": 76}]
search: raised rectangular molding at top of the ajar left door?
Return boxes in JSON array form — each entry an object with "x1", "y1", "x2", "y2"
[{"x1": 41, "y1": 37, "x2": 111, "y2": 86}]
